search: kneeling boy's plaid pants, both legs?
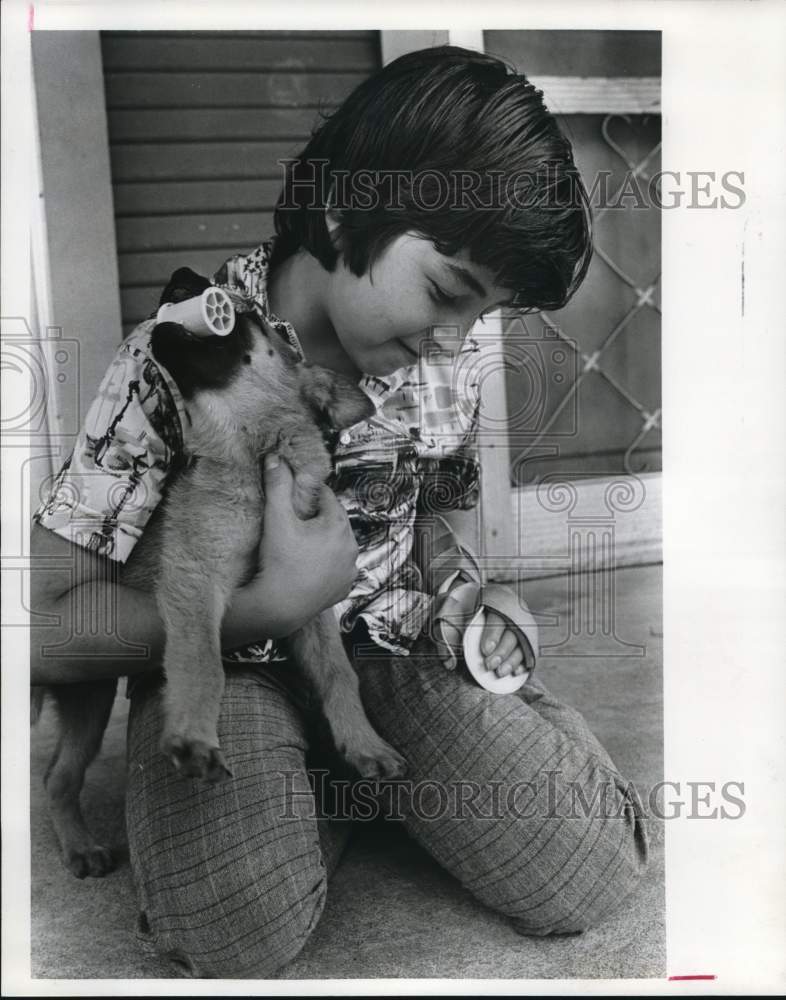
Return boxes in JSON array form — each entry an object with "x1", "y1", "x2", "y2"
[{"x1": 127, "y1": 638, "x2": 647, "y2": 978}]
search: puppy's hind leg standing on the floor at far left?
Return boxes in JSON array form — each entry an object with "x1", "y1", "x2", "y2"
[{"x1": 44, "y1": 680, "x2": 117, "y2": 878}]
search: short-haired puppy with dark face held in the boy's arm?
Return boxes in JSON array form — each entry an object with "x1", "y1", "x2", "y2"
[{"x1": 34, "y1": 268, "x2": 405, "y2": 878}]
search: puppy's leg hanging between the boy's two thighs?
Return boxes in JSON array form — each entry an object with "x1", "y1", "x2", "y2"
[{"x1": 289, "y1": 609, "x2": 407, "y2": 778}]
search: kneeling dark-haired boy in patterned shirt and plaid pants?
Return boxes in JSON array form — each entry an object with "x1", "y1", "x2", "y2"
[{"x1": 32, "y1": 47, "x2": 646, "y2": 977}]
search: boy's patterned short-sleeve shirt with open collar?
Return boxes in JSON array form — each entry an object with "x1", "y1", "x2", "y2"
[{"x1": 34, "y1": 234, "x2": 479, "y2": 662}]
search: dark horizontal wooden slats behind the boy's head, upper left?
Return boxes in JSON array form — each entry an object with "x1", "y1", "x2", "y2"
[{"x1": 101, "y1": 31, "x2": 380, "y2": 333}]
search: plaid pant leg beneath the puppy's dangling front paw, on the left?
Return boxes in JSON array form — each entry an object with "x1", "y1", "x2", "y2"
[{"x1": 126, "y1": 667, "x2": 348, "y2": 978}]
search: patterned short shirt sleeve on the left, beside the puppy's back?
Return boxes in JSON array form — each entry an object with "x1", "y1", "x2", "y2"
[{"x1": 33, "y1": 321, "x2": 184, "y2": 562}]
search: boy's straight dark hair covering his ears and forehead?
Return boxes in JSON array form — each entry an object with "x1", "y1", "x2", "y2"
[{"x1": 272, "y1": 45, "x2": 592, "y2": 309}]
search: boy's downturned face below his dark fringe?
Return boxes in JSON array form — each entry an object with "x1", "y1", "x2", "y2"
[{"x1": 324, "y1": 233, "x2": 513, "y2": 375}]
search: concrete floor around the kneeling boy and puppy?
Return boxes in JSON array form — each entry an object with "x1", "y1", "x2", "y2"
[{"x1": 31, "y1": 566, "x2": 666, "y2": 979}]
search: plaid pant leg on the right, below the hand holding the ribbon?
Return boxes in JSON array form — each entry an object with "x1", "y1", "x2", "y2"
[{"x1": 357, "y1": 638, "x2": 647, "y2": 934}]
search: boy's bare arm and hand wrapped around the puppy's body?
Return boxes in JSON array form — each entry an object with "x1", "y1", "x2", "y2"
[{"x1": 30, "y1": 463, "x2": 357, "y2": 684}]
